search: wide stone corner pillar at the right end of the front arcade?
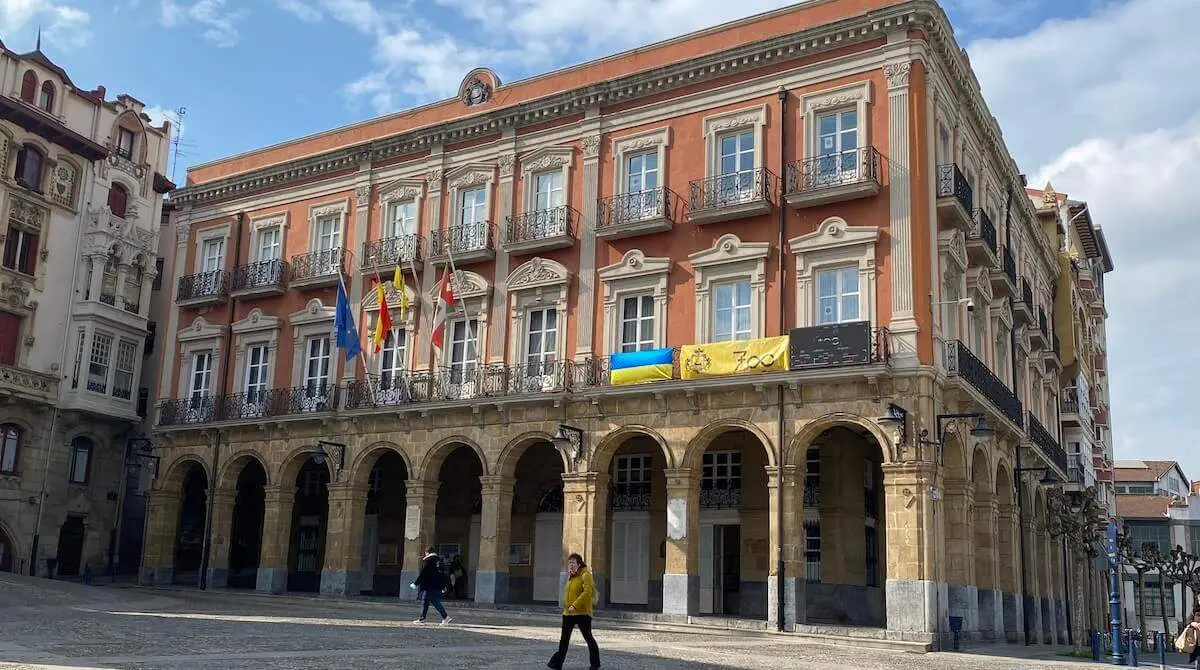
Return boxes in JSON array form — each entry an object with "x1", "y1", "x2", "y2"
[{"x1": 878, "y1": 462, "x2": 948, "y2": 638}]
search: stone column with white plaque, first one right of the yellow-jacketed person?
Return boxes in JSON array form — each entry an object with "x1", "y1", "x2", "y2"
[{"x1": 662, "y1": 467, "x2": 700, "y2": 616}]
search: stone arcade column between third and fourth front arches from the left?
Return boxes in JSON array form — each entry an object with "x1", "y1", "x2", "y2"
[{"x1": 320, "y1": 481, "x2": 367, "y2": 597}]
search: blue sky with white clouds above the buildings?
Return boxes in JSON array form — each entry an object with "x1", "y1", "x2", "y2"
[{"x1": 0, "y1": 0, "x2": 1200, "y2": 479}]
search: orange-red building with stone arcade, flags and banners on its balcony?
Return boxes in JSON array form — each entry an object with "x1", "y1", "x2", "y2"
[{"x1": 143, "y1": 0, "x2": 1099, "y2": 641}]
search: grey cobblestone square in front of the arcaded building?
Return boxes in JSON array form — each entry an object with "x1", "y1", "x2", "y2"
[{"x1": 0, "y1": 574, "x2": 1185, "y2": 670}]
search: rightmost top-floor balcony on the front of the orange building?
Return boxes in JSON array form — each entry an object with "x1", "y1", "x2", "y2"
[{"x1": 784, "y1": 146, "x2": 881, "y2": 209}]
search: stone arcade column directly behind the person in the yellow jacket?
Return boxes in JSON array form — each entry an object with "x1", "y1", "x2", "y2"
[{"x1": 558, "y1": 472, "x2": 610, "y2": 606}]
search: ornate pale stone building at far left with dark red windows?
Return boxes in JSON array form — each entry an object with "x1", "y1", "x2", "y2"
[{"x1": 0, "y1": 44, "x2": 170, "y2": 576}]
